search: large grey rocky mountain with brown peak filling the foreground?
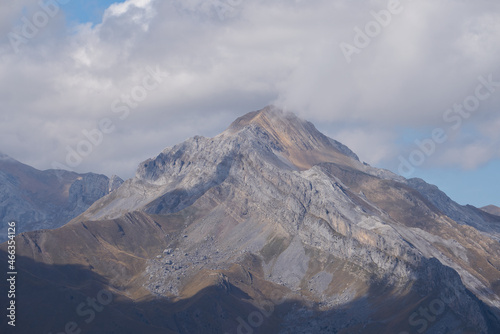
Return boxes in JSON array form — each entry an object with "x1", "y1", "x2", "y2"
[{"x1": 0, "y1": 107, "x2": 500, "y2": 334}]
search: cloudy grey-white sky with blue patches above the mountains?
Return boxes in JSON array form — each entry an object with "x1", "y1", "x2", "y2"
[{"x1": 0, "y1": 0, "x2": 500, "y2": 207}]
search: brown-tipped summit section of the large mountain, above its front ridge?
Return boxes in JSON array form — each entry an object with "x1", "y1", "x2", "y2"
[{"x1": 79, "y1": 106, "x2": 368, "y2": 219}]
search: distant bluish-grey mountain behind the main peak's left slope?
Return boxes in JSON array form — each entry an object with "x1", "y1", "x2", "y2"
[{"x1": 0, "y1": 153, "x2": 123, "y2": 242}]
